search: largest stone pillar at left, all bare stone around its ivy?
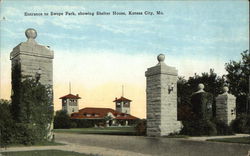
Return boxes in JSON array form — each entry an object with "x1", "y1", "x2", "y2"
[{"x1": 10, "y1": 28, "x2": 54, "y2": 139}]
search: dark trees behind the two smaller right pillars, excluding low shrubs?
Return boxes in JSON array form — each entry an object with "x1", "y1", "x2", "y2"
[{"x1": 177, "y1": 50, "x2": 250, "y2": 120}]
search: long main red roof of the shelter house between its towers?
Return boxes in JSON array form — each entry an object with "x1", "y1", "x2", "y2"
[{"x1": 71, "y1": 107, "x2": 138, "y2": 120}]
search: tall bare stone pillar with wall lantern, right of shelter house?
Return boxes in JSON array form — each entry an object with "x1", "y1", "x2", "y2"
[{"x1": 145, "y1": 54, "x2": 181, "y2": 136}]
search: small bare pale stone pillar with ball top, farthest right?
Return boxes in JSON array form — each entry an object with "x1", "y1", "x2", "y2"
[{"x1": 216, "y1": 87, "x2": 236, "y2": 125}]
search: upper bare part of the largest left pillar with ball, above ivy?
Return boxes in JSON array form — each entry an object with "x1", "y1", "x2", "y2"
[{"x1": 10, "y1": 28, "x2": 54, "y2": 86}]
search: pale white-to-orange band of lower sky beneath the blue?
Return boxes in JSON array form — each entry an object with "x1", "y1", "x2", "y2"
[{"x1": 0, "y1": 49, "x2": 229, "y2": 117}]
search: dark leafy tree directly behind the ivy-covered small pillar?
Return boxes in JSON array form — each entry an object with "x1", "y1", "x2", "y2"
[{"x1": 177, "y1": 69, "x2": 225, "y2": 120}]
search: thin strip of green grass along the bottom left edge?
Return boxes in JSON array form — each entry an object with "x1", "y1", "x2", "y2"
[{"x1": 2, "y1": 150, "x2": 97, "y2": 156}]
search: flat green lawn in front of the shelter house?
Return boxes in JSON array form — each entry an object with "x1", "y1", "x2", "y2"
[{"x1": 54, "y1": 127, "x2": 136, "y2": 135}]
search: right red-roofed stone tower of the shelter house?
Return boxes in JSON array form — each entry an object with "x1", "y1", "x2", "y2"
[{"x1": 113, "y1": 96, "x2": 131, "y2": 114}]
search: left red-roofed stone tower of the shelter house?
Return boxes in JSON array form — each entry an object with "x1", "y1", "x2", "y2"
[{"x1": 59, "y1": 93, "x2": 81, "y2": 115}]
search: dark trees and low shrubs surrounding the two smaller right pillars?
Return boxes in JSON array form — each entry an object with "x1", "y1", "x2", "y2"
[{"x1": 177, "y1": 50, "x2": 250, "y2": 135}]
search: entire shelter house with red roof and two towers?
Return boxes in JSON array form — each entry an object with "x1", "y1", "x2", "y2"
[{"x1": 60, "y1": 94, "x2": 139, "y2": 126}]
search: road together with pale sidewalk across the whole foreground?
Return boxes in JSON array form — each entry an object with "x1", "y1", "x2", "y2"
[{"x1": 0, "y1": 133, "x2": 250, "y2": 156}]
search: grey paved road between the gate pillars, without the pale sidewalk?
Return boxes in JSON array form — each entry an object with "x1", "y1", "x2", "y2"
[{"x1": 56, "y1": 133, "x2": 250, "y2": 156}]
